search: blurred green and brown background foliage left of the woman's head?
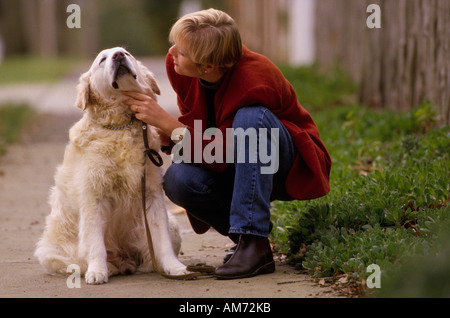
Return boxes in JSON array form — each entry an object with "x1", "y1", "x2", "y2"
[{"x1": 0, "y1": 0, "x2": 224, "y2": 58}]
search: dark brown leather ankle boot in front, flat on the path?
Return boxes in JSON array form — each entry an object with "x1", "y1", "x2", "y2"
[{"x1": 214, "y1": 235, "x2": 275, "y2": 279}]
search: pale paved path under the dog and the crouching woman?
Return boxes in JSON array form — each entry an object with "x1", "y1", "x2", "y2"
[{"x1": 0, "y1": 59, "x2": 337, "y2": 298}]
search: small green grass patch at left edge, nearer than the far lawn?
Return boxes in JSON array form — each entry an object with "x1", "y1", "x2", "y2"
[{"x1": 0, "y1": 103, "x2": 34, "y2": 156}]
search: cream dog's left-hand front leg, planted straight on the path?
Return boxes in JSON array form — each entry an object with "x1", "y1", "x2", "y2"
[{"x1": 79, "y1": 202, "x2": 108, "y2": 284}]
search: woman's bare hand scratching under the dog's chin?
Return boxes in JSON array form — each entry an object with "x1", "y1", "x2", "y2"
[{"x1": 122, "y1": 91, "x2": 184, "y2": 136}]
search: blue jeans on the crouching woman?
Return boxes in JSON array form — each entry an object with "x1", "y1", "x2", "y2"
[{"x1": 164, "y1": 106, "x2": 296, "y2": 238}]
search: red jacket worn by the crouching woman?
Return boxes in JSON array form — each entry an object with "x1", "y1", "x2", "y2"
[{"x1": 166, "y1": 46, "x2": 331, "y2": 200}]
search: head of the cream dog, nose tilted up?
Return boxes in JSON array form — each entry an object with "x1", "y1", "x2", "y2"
[{"x1": 75, "y1": 47, "x2": 160, "y2": 110}]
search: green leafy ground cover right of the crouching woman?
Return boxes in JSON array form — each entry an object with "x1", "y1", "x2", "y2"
[{"x1": 271, "y1": 67, "x2": 450, "y2": 295}]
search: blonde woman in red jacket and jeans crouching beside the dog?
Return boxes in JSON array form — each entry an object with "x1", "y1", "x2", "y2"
[{"x1": 124, "y1": 9, "x2": 331, "y2": 279}]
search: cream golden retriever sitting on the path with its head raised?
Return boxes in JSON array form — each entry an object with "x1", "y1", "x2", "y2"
[{"x1": 35, "y1": 47, "x2": 189, "y2": 284}]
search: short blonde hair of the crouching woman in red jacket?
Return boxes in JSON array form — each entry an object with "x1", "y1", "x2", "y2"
[{"x1": 169, "y1": 9, "x2": 242, "y2": 68}]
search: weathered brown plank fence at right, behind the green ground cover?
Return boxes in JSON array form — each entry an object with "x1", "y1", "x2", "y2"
[{"x1": 315, "y1": 0, "x2": 450, "y2": 124}]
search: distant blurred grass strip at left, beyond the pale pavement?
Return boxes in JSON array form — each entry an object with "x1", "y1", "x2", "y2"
[{"x1": 0, "y1": 56, "x2": 79, "y2": 84}]
